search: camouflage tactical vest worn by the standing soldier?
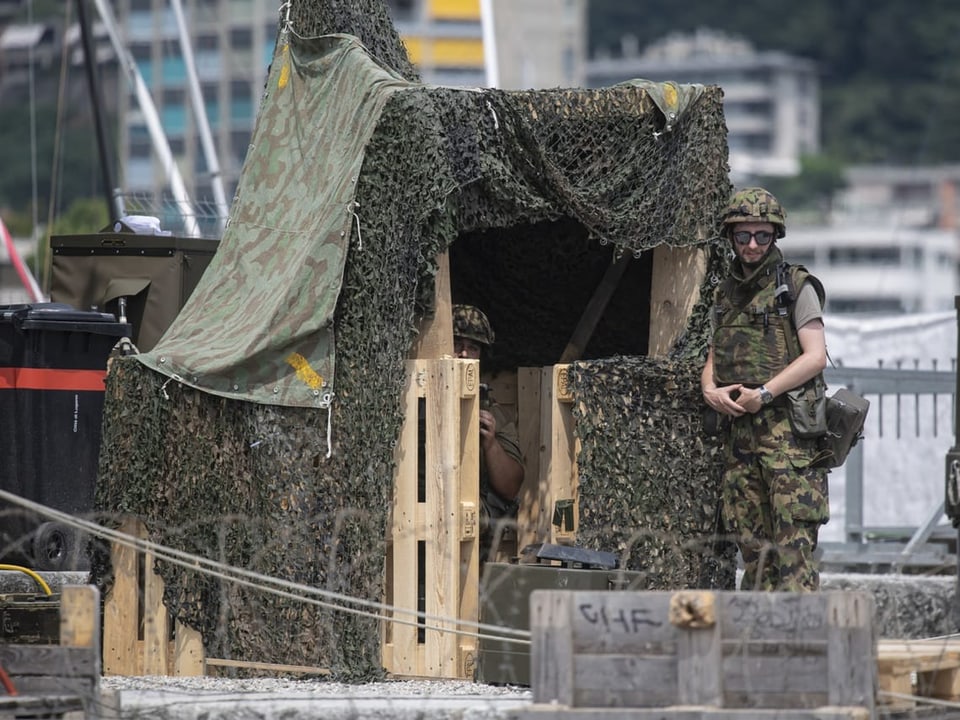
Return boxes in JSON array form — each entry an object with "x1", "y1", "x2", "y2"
[{"x1": 713, "y1": 263, "x2": 824, "y2": 387}]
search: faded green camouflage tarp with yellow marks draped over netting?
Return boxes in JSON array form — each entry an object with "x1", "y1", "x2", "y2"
[{"x1": 138, "y1": 35, "x2": 413, "y2": 407}]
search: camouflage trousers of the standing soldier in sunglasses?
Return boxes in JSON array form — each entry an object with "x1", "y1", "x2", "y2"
[{"x1": 722, "y1": 405, "x2": 830, "y2": 592}]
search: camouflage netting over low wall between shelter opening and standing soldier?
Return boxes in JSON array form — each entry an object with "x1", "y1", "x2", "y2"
[{"x1": 570, "y1": 357, "x2": 736, "y2": 590}]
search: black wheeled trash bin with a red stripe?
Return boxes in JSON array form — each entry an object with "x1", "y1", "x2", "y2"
[{"x1": 0, "y1": 303, "x2": 130, "y2": 570}]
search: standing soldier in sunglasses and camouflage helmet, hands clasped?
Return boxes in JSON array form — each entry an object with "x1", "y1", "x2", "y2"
[{"x1": 701, "y1": 188, "x2": 829, "y2": 591}]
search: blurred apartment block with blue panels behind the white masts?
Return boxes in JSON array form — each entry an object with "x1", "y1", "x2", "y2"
[{"x1": 116, "y1": 0, "x2": 278, "y2": 229}]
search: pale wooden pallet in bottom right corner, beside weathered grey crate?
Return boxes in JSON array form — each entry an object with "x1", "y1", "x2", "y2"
[{"x1": 877, "y1": 639, "x2": 960, "y2": 710}]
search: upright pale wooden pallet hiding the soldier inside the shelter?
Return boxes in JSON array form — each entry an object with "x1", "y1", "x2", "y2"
[{"x1": 382, "y1": 358, "x2": 480, "y2": 679}]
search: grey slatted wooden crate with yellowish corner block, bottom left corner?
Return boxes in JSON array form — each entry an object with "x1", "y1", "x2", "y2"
[{"x1": 0, "y1": 585, "x2": 100, "y2": 718}]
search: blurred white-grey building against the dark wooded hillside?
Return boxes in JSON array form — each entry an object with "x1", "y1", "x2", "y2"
[{"x1": 586, "y1": 30, "x2": 820, "y2": 180}]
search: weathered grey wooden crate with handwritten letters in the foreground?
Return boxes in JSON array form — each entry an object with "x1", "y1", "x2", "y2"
[{"x1": 525, "y1": 590, "x2": 876, "y2": 718}]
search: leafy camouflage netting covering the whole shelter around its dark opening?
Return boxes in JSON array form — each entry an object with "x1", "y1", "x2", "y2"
[{"x1": 95, "y1": 0, "x2": 730, "y2": 680}]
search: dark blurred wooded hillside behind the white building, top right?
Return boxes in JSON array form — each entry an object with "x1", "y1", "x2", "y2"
[{"x1": 589, "y1": 0, "x2": 960, "y2": 164}]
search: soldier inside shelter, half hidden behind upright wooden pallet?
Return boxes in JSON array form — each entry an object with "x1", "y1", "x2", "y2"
[{"x1": 453, "y1": 305, "x2": 524, "y2": 564}]
